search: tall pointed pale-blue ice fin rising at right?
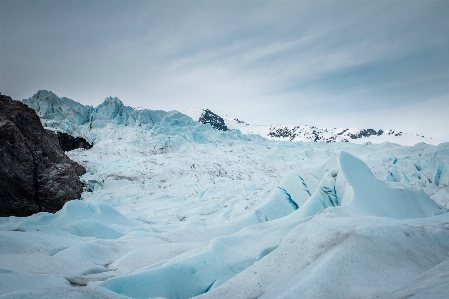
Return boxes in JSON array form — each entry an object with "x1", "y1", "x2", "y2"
[{"x1": 297, "y1": 152, "x2": 447, "y2": 219}]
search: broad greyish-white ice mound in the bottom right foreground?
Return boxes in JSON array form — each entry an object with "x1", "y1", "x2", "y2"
[{"x1": 198, "y1": 213, "x2": 449, "y2": 299}]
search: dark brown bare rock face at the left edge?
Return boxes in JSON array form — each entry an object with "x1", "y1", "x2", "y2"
[{"x1": 0, "y1": 95, "x2": 86, "y2": 217}]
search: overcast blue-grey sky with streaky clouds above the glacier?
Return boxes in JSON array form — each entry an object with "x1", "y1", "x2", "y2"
[{"x1": 0, "y1": 0, "x2": 449, "y2": 141}]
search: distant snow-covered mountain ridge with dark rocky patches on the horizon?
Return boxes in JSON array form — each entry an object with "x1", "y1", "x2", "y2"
[{"x1": 182, "y1": 108, "x2": 441, "y2": 145}]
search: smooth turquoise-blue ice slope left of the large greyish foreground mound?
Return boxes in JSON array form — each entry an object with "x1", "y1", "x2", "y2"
[{"x1": 101, "y1": 217, "x2": 298, "y2": 298}]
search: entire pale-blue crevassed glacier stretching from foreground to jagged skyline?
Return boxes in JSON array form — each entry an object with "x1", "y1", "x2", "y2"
[{"x1": 0, "y1": 94, "x2": 449, "y2": 298}]
